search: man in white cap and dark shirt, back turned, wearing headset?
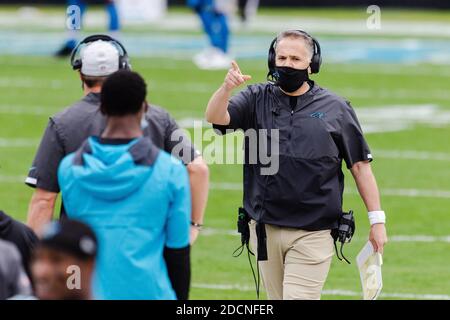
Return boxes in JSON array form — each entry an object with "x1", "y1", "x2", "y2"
[{"x1": 25, "y1": 35, "x2": 209, "y2": 244}]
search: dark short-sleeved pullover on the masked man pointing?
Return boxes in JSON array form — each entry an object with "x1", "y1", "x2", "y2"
[{"x1": 214, "y1": 81, "x2": 372, "y2": 231}]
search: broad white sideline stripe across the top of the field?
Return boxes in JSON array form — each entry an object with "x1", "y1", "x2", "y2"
[{"x1": 0, "y1": 10, "x2": 450, "y2": 37}]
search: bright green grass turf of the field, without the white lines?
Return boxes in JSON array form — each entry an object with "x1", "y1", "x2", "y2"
[{"x1": 0, "y1": 5, "x2": 450, "y2": 299}]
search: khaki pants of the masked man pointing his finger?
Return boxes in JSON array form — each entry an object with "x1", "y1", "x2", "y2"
[{"x1": 249, "y1": 220, "x2": 334, "y2": 300}]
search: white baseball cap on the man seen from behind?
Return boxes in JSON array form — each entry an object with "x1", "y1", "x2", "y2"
[{"x1": 80, "y1": 40, "x2": 119, "y2": 77}]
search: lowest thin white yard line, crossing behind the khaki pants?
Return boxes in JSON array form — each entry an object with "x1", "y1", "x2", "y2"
[{"x1": 192, "y1": 283, "x2": 450, "y2": 300}]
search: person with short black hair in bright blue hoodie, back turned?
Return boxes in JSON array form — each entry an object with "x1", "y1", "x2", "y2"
[{"x1": 58, "y1": 70, "x2": 191, "y2": 300}]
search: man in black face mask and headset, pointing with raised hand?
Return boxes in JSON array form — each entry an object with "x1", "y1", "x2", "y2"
[{"x1": 205, "y1": 30, "x2": 387, "y2": 299}]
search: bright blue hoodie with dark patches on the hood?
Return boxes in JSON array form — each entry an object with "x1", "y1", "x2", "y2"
[{"x1": 58, "y1": 137, "x2": 191, "y2": 299}]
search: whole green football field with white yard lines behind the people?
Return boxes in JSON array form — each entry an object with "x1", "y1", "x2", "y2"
[{"x1": 0, "y1": 7, "x2": 450, "y2": 299}]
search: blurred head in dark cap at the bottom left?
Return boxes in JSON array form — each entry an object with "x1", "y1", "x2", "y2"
[{"x1": 31, "y1": 219, "x2": 97, "y2": 300}]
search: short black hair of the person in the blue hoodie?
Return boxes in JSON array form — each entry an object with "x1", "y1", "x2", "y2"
[{"x1": 100, "y1": 70, "x2": 147, "y2": 117}]
